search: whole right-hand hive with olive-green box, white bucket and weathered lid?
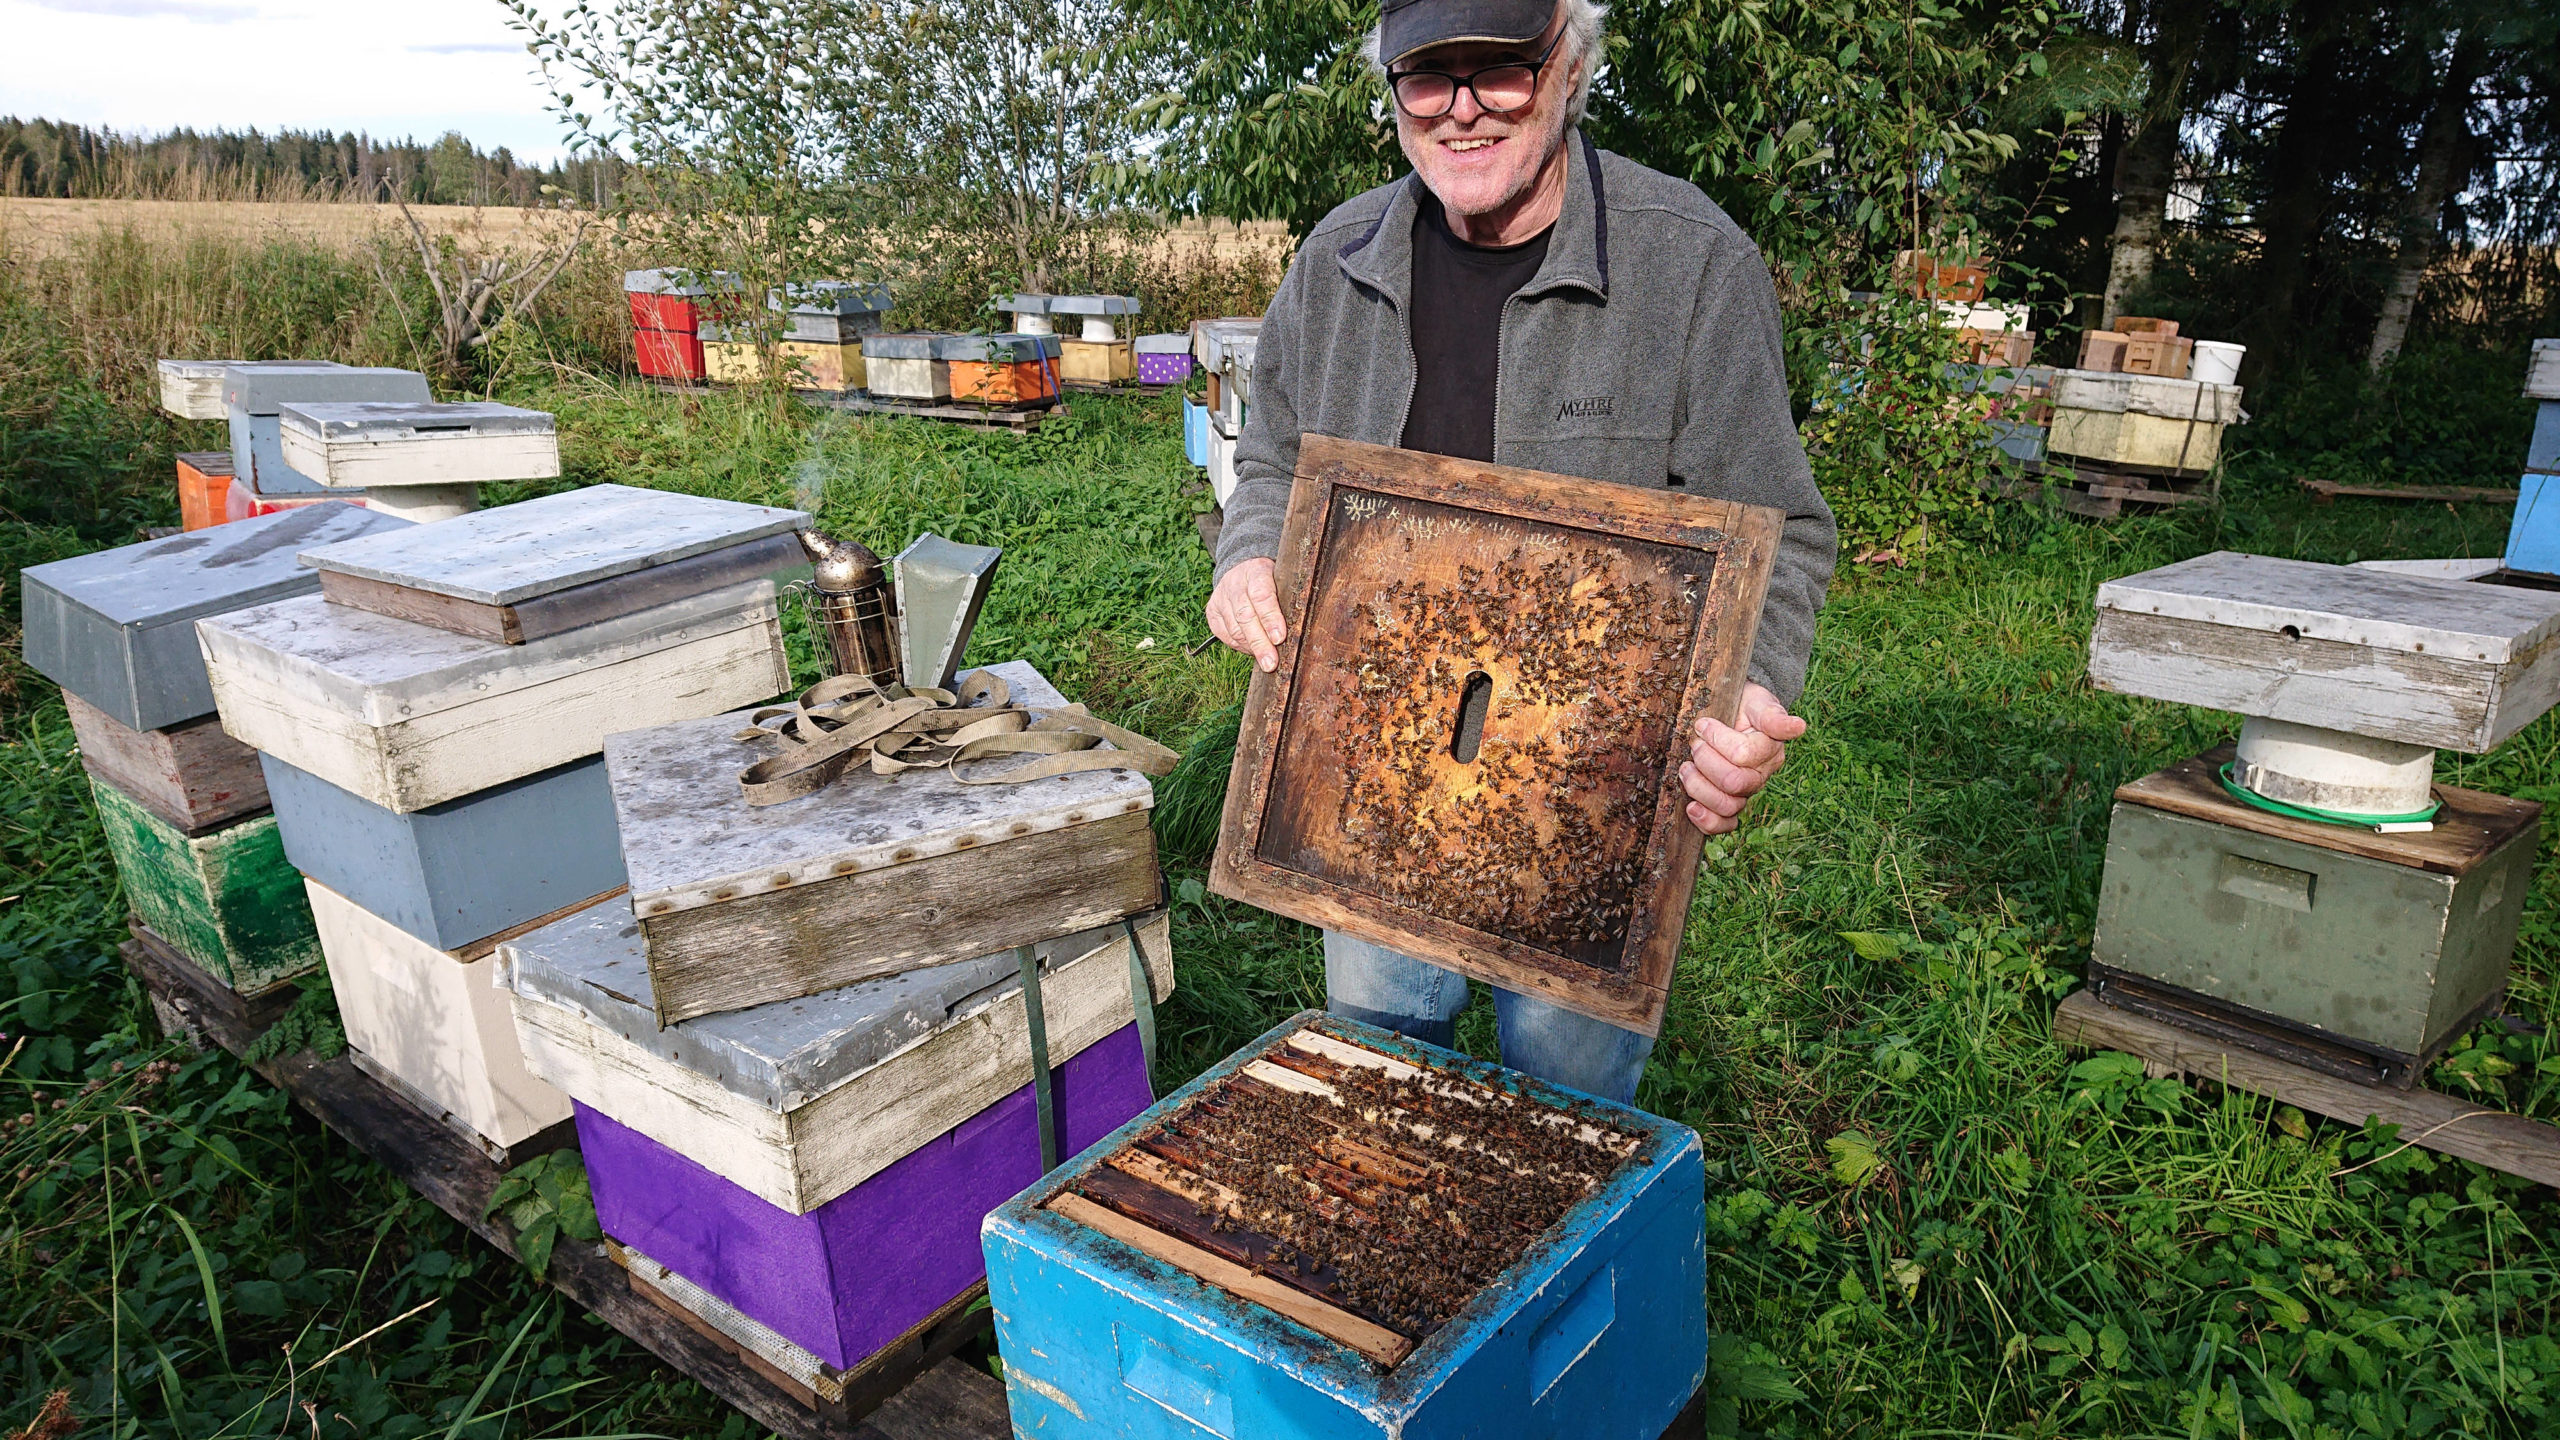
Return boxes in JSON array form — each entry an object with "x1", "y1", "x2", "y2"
[{"x1": 2089, "y1": 551, "x2": 2560, "y2": 1084}]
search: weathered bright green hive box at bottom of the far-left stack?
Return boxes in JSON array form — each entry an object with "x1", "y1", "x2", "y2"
[{"x1": 90, "y1": 779, "x2": 320, "y2": 997}]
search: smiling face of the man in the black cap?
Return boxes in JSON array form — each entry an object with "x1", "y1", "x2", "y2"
[{"x1": 1395, "y1": 15, "x2": 1574, "y2": 215}]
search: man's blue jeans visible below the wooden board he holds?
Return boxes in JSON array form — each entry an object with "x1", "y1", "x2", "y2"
[{"x1": 1324, "y1": 930, "x2": 1654, "y2": 1104}]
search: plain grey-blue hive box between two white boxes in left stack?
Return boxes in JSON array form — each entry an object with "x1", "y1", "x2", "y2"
[{"x1": 259, "y1": 756, "x2": 625, "y2": 951}]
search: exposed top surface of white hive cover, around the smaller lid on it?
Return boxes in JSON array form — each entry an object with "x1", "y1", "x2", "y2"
[{"x1": 197, "y1": 576, "x2": 773, "y2": 725}]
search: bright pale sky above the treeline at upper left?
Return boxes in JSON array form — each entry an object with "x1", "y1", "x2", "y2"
[{"x1": 0, "y1": 0, "x2": 563, "y2": 161}]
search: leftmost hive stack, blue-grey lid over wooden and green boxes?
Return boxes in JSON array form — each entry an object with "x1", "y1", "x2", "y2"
[{"x1": 20, "y1": 505, "x2": 410, "y2": 1002}]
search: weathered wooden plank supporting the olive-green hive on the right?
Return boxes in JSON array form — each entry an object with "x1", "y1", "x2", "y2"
[{"x1": 2053, "y1": 989, "x2": 2560, "y2": 1186}]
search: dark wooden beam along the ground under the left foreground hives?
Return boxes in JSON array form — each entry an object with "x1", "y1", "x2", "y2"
[{"x1": 125, "y1": 933, "x2": 1009, "y2": 1440}]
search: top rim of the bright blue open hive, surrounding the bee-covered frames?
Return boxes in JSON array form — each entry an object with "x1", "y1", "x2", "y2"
[{"x1": 986, "y1": 1010, "x2": 1702, "y2": 1414}]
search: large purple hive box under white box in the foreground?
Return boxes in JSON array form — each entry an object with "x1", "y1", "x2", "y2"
[{"x1": 576, "y1": 1025, "x2": 1155, "y2": 1371}]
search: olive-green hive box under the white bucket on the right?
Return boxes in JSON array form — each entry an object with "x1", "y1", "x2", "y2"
[{"x1": 2089, "y1": 746, "x2": 2542, "y2": 1084}]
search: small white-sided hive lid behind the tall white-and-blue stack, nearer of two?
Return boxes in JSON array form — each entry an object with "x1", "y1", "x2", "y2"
[{"x1": 276, "y1": 400, "x2": 561, "y2": 523}]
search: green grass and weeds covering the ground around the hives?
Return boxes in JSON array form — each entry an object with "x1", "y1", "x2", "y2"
[{"x1": 0, "y1": 341, "x2": 2560, "y2": 1437}]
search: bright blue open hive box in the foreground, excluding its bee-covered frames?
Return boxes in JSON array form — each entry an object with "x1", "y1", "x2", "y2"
[{"x1": 986, "y1": 1012, "x2": 1708, "y2": 1440}]
